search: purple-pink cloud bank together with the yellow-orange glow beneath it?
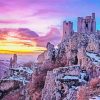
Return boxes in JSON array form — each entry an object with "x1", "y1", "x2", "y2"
[{"x1": 0, "y1": 27, "x2": 61, "y2": 53}]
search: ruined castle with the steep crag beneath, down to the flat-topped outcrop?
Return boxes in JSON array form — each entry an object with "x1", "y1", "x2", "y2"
[{"x1": 38, "y1": 13, "x2": 100, "y2": 75}]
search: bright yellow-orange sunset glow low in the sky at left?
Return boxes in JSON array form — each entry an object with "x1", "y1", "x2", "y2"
[{"x1": 0, "y1": 32, "x2": 46, "y2": 53}]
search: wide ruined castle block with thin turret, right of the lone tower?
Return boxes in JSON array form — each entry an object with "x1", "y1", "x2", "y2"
[{"x1": 77, "y1": 13, "x2": 96, "y2": 34}]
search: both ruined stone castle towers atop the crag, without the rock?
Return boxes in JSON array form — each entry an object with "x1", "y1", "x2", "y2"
[{"x1": 63, "y1": 13, "x2": 96, "y2": 40}]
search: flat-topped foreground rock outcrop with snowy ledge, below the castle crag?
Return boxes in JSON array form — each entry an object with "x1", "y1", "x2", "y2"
[{"x1": 42, "y1": 66, "x2": 88, "y2": 100}]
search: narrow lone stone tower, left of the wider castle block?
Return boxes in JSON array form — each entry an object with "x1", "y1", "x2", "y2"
[{"x1": 62, "y1": 21, "x2": 73, "y2": 41}]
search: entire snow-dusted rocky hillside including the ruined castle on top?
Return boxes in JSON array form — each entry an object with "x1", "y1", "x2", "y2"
[{"x1": 0, "y1": 13, "x2": 100, "y2": 100}]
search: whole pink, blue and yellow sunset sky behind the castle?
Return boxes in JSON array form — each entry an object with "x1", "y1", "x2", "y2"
[{"x1": 0, "y1": 0, "x2": 100, "y2": 52}]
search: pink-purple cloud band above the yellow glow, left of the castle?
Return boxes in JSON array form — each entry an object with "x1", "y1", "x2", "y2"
[{"x1": 0, "y1": 27, "x2": 61, "y2": 47}]
